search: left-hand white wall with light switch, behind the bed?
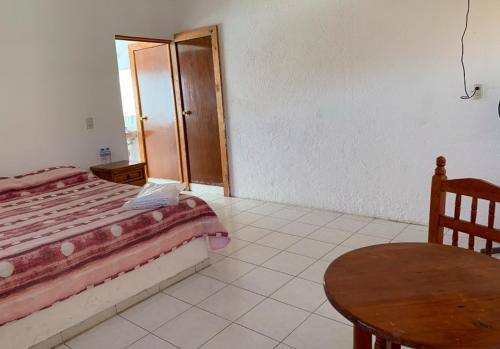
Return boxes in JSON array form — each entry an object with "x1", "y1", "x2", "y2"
[{"x1": 0, "y1": 0, "x2": 173, "y2": 176}]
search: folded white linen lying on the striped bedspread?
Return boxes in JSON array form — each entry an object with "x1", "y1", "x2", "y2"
[{"x1": 123, "y1": 183, "x2": 184, "y2": 210}]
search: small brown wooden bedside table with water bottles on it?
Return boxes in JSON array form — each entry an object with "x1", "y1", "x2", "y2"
[{"x1": 90, "y1": 161, "x2": 147, "y2": 186}]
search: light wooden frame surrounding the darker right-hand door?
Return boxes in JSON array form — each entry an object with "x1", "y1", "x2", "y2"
[{"x1": 170, "y1": 25, "x2": 231, "y2": 196}]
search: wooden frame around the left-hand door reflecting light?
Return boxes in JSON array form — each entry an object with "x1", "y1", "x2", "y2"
[{"x1": 125, "y1": 35, "x2": 183, "y2": 180}]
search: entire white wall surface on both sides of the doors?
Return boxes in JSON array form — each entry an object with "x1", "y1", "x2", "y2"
[{"x1": 0, "y1": 0, "x2": 500, "y2": 222}]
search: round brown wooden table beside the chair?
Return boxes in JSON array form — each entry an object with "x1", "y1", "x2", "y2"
[{"x1": 324, "y1": 243, "x2": 500, "y2": 349}]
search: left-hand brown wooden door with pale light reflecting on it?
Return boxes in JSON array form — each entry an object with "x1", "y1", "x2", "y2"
[{"x1": 129, "y1": 42, "x2": 182, "y2": 180}]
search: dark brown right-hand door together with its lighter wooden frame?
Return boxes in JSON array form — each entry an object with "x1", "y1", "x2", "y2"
[{"x1": 172, "y1": 26, "x2": 230, "y2": 196}]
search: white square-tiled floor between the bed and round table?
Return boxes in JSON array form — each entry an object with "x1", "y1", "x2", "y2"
[{"x1": 58, "y1": 192, "x2": 427, "y2": 349}]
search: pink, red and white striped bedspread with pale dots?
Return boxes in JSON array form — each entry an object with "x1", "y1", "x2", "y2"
[{"x1": 0, "y1": 167, "x2": 229, "y2": 325}]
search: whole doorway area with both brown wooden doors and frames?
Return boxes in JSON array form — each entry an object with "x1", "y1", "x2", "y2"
[{"x1": 116, "y1": 26, "x2": 230, "y2": 196}]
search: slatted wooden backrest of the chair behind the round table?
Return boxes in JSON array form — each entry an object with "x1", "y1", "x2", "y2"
[{"x1": 429, "y1": 156, "x2": 500, "y2": 255}]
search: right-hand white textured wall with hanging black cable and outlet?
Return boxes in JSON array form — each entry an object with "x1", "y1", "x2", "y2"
[{"x1": 176, "y1": 0, "x2": 500, "y2": 222}]
